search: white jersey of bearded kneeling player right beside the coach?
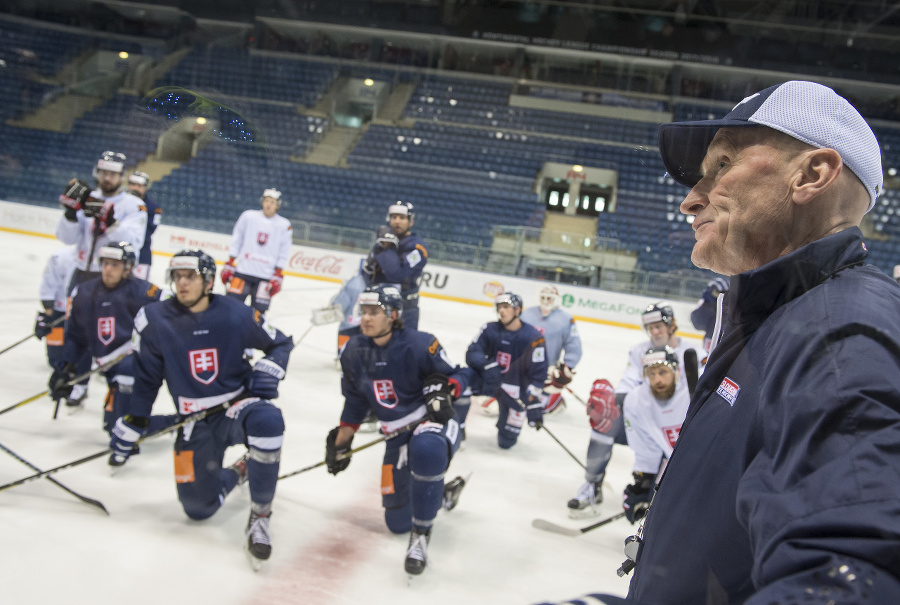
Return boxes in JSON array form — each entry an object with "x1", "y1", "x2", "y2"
[{"x1": 622, "y1": 380, "x2": 691, "y2": 474}]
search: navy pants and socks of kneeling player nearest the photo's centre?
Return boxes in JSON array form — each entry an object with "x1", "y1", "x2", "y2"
[{"x1": 381, "y1": 420, "x2": 459, "y2": 534}]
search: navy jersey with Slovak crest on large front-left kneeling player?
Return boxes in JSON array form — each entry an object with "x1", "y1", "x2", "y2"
[{"x1": 128, "y1": 294, "x2": 294, "y2": 416}]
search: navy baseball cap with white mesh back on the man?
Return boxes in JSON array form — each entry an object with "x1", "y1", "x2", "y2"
[{"x1": 659, "y1": 80, "x2": 884, "y2": 210}]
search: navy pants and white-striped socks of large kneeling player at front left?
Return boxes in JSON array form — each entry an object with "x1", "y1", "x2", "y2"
[{"x1": 169, "y1": 397, "x2": 284, "y2": 520}]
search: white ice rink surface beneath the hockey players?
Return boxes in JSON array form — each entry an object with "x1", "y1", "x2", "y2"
[{"x1": 0, "y1": 232, "x2": 701, "y2": 605}]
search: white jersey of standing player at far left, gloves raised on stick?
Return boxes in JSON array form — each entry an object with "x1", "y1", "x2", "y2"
[{"x1": 56, "y1": 189, "x2": 147, "y2": 271}]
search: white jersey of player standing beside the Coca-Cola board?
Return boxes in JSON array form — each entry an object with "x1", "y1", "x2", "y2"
[{"x1": 228, "y1": 210, "x2": 293, "y2": 280}]
